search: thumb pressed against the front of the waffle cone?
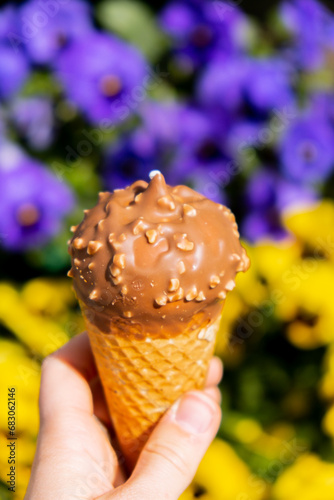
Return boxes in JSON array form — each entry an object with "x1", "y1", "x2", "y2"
[{"x1": 112, "y1": 391, "x2": 221, "y2": 500}]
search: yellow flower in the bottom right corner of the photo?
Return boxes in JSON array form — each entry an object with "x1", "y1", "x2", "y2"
[{"x1": 272, "y1": 454, "x2": 334, "y2": 500}]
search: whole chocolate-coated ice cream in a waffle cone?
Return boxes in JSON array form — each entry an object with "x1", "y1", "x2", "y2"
[{"x1": 69, "y1": 173, "x2": 249, "y2": 471}]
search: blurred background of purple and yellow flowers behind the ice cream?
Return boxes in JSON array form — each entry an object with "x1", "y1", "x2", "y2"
[{"x1": 0, "y1": 0, "x2": 334, "y2": 500}]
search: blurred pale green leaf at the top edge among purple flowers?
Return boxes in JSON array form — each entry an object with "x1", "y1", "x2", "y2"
[{"x1": 97, "y1": 0, "x2": 168, "y2": 61}]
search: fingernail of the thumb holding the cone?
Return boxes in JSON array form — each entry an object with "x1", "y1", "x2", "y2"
[{"x1": 174, "y1": 393, "x2": 214, "y2": 434}]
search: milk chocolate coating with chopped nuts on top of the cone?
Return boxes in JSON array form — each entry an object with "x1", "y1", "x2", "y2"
[{"x1": 69, "y1": 174, "x2": 249, "y2": 337}]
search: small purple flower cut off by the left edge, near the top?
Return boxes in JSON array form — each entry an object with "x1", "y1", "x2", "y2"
[{"x1": 0, "y1": 44, "x2": 29, "y2": 100}]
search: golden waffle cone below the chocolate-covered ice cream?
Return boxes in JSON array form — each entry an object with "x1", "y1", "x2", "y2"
[{"x1": 86, "y1": 317, "x2": 219, "y2": 471}]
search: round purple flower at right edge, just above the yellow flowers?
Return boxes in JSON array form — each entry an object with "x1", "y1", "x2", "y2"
[{"x1": 278, "y1": 113, "x2": 334, "y2": 183}]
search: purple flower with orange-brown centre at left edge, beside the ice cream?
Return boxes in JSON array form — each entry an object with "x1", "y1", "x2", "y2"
[{"x1": 0, "y1": 143, "x2": 74, "y2": 251}]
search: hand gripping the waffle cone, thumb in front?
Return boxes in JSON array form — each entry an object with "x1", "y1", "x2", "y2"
[{"x1": 25, "y1": 333, "x2": 222, "y2": 500}]
